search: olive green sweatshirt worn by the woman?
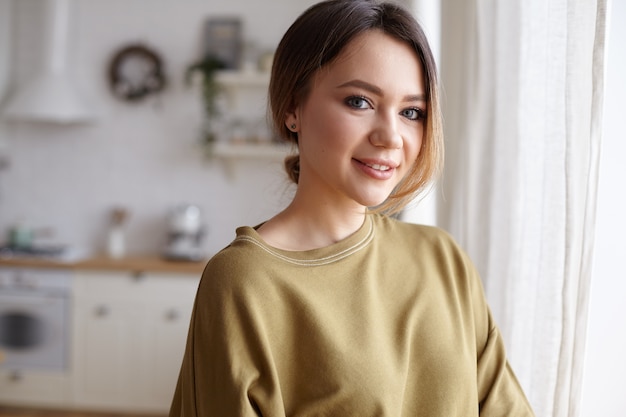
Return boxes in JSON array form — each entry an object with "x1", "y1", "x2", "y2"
[{"x1": 170, "y1": 214, "x2": 533, "y2": 417}]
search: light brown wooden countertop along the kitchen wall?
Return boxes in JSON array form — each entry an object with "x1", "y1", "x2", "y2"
[{"x1": 0, "y1": 255, "x2": 208, "y2": 276}]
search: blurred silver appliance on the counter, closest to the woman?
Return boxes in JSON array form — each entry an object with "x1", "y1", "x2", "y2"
[{"x1": 163, "y1": 205, "x2": 206, "y2": 261}]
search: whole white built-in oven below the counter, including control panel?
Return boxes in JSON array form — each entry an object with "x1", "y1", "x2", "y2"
[{"x1": 0, "y1": 268, "x2": 71, "y2": 371}]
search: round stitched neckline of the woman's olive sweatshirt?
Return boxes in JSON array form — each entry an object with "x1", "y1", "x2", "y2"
[{"x1": 233, "y1": 214, "x2": 374, "y2": 266}]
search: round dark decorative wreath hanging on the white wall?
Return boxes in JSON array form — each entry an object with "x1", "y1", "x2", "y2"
[{"x1": 109, "y1": 44, "x2": 166, "y2": 101}]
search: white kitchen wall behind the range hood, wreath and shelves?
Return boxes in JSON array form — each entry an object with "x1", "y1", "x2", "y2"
[{"x1": 0, "y1": 0, "x2": 322, "y2": 252}]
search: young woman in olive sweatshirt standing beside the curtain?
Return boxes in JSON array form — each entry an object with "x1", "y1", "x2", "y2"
[{"x1": 170, "y1": 0, "x2": 533, "y2": 417}]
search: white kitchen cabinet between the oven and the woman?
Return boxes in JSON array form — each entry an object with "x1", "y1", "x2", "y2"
[{"x1": 73, "y1": 271, "x2": 199, "y2": 413}]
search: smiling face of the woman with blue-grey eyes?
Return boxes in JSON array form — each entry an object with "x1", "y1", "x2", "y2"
[{"x1": 285, "y1": 30, "x2": 426, "y2": 207}]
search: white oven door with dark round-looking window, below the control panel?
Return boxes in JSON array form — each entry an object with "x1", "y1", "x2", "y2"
[{"x1": 0, "y1": 291, "x2": 68, "y2": 370}]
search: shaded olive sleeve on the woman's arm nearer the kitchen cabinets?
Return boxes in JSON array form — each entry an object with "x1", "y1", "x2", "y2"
[{"x1": 170, "y1": 255, "x2": 284, "y2": 417}]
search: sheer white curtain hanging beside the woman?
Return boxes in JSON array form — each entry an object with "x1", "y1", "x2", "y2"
[{"x1": 438, "y1": 0, "x2": 607, "y2": 417}]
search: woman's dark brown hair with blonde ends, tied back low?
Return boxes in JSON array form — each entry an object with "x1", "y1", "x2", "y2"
[{"x1": 269, "y1": 0, "x2": 443, "y2": 213}]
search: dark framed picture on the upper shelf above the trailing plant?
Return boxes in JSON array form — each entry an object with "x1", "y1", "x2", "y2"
[{"x1": 204, "y1": 17, "x2": 243, "y2": 69}]
